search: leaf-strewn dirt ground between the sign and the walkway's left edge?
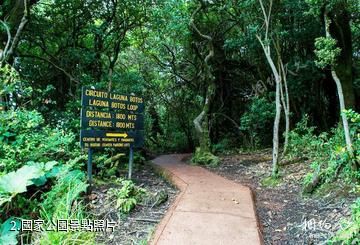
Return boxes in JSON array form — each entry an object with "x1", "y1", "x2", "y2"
[{"x1": 90, "y1": 164, "x2": 177, "y2": 245}]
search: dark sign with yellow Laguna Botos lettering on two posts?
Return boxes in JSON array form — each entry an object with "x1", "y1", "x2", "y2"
[{"x1": 80, "y1": 87, "x2": 144, "y2": 192}]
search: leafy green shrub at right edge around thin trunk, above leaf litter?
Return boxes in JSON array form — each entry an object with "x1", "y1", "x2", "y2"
[{"x1": 288, "y1": 110, "x2": 360, "y2": 192}]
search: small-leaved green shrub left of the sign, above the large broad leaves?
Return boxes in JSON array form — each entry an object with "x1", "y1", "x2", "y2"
[{"x1": 0, "y1": 110, "x2": 77, "y2": 173}]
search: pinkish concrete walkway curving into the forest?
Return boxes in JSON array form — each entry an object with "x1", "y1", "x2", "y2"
[{"x1": 151, "y1": 155, "x2": 262, "y2": 245}]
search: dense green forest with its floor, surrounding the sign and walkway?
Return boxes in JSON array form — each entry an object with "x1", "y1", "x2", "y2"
[{"x1": 0, "y1": 0, "x2": 360, "y2": 245}]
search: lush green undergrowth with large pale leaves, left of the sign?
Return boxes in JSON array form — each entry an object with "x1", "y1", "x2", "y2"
[{"x1": 0, "y1": 110, "x2": 94, "y2": 245}]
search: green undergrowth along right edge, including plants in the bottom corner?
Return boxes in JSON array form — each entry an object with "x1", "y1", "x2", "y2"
[{"x1": 288, "y1": 110, "x2": 360, "y2": 244}]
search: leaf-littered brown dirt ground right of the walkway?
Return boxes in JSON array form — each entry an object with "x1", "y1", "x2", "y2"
[{"x1": 202, "y1": 151, "x2": 356, "y2": 245}]
